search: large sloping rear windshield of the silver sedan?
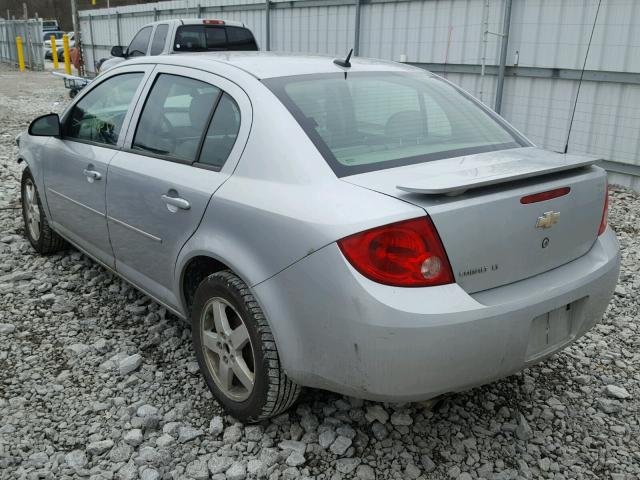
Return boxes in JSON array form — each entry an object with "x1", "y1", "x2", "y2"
[{"x1": 264, "y1": 72, "x2": 527, "y2": 176}]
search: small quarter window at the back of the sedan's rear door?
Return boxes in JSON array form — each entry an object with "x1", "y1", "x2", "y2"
[{"x1": 198, "y1": 93, "x2": 240, "y2": 167}]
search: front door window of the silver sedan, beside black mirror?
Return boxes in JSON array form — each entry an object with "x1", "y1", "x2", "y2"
[{"x1": 65, "y1": 73, "x2": 144, "y2": 145}]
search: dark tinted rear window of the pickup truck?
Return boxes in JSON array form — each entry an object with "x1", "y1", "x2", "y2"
[{"x1": 174, "y1": 25, "x2": 258, "y2": 52}]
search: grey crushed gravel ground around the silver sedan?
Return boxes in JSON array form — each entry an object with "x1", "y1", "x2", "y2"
[{"x1": 0, "y1": 65, "x2": 640, "y2": 480}]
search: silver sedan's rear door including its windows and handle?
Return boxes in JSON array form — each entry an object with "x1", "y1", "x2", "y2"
[{"x1": 107, "y1": 65, "x2": 251, "y2": 306}]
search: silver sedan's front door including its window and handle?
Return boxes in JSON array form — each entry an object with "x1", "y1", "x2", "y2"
[{"x1": 45, "y1": 69, "x2": 150, "y2": 268}]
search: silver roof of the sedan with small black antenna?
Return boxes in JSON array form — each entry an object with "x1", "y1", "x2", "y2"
[{"x1": 126, "y1": 51, "x2": 425, "y2": 79}]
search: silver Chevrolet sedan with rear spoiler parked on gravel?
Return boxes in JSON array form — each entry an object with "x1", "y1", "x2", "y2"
[{"x1": 18, "y1": 53, "x2": 619, "y2": 421}]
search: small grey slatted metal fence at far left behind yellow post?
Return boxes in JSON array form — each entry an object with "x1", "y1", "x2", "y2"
[{"x1": 0, "y1": 19, "x2": 44, "y2": 70}]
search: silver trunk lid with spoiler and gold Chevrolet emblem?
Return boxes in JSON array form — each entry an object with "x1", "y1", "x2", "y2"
[{"x1": 342, "y1": 147, "x2": 606, "y2": 293}]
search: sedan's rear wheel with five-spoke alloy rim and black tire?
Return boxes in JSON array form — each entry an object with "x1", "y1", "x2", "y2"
[{"x1": 191, "y1": 270, "x2": 302, "y2": 423}]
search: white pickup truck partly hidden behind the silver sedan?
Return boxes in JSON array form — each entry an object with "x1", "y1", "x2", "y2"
[{"x1": 96, "y1": 19, "x2": 258, "y2": 72}]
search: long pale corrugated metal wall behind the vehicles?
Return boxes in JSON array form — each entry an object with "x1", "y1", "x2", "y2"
[{"x1": 80, "y1": 0, "x2": 640, "y2": 190}]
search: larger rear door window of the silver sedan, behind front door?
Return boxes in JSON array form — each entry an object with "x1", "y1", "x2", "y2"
[{"x1": 132, "y1": 74, "x2": 220, "y2": 162}]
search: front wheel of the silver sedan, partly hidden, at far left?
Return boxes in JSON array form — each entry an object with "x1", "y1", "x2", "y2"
[{"x1": 20, "y1": 168, "x2": 66, "y2": 255}]
